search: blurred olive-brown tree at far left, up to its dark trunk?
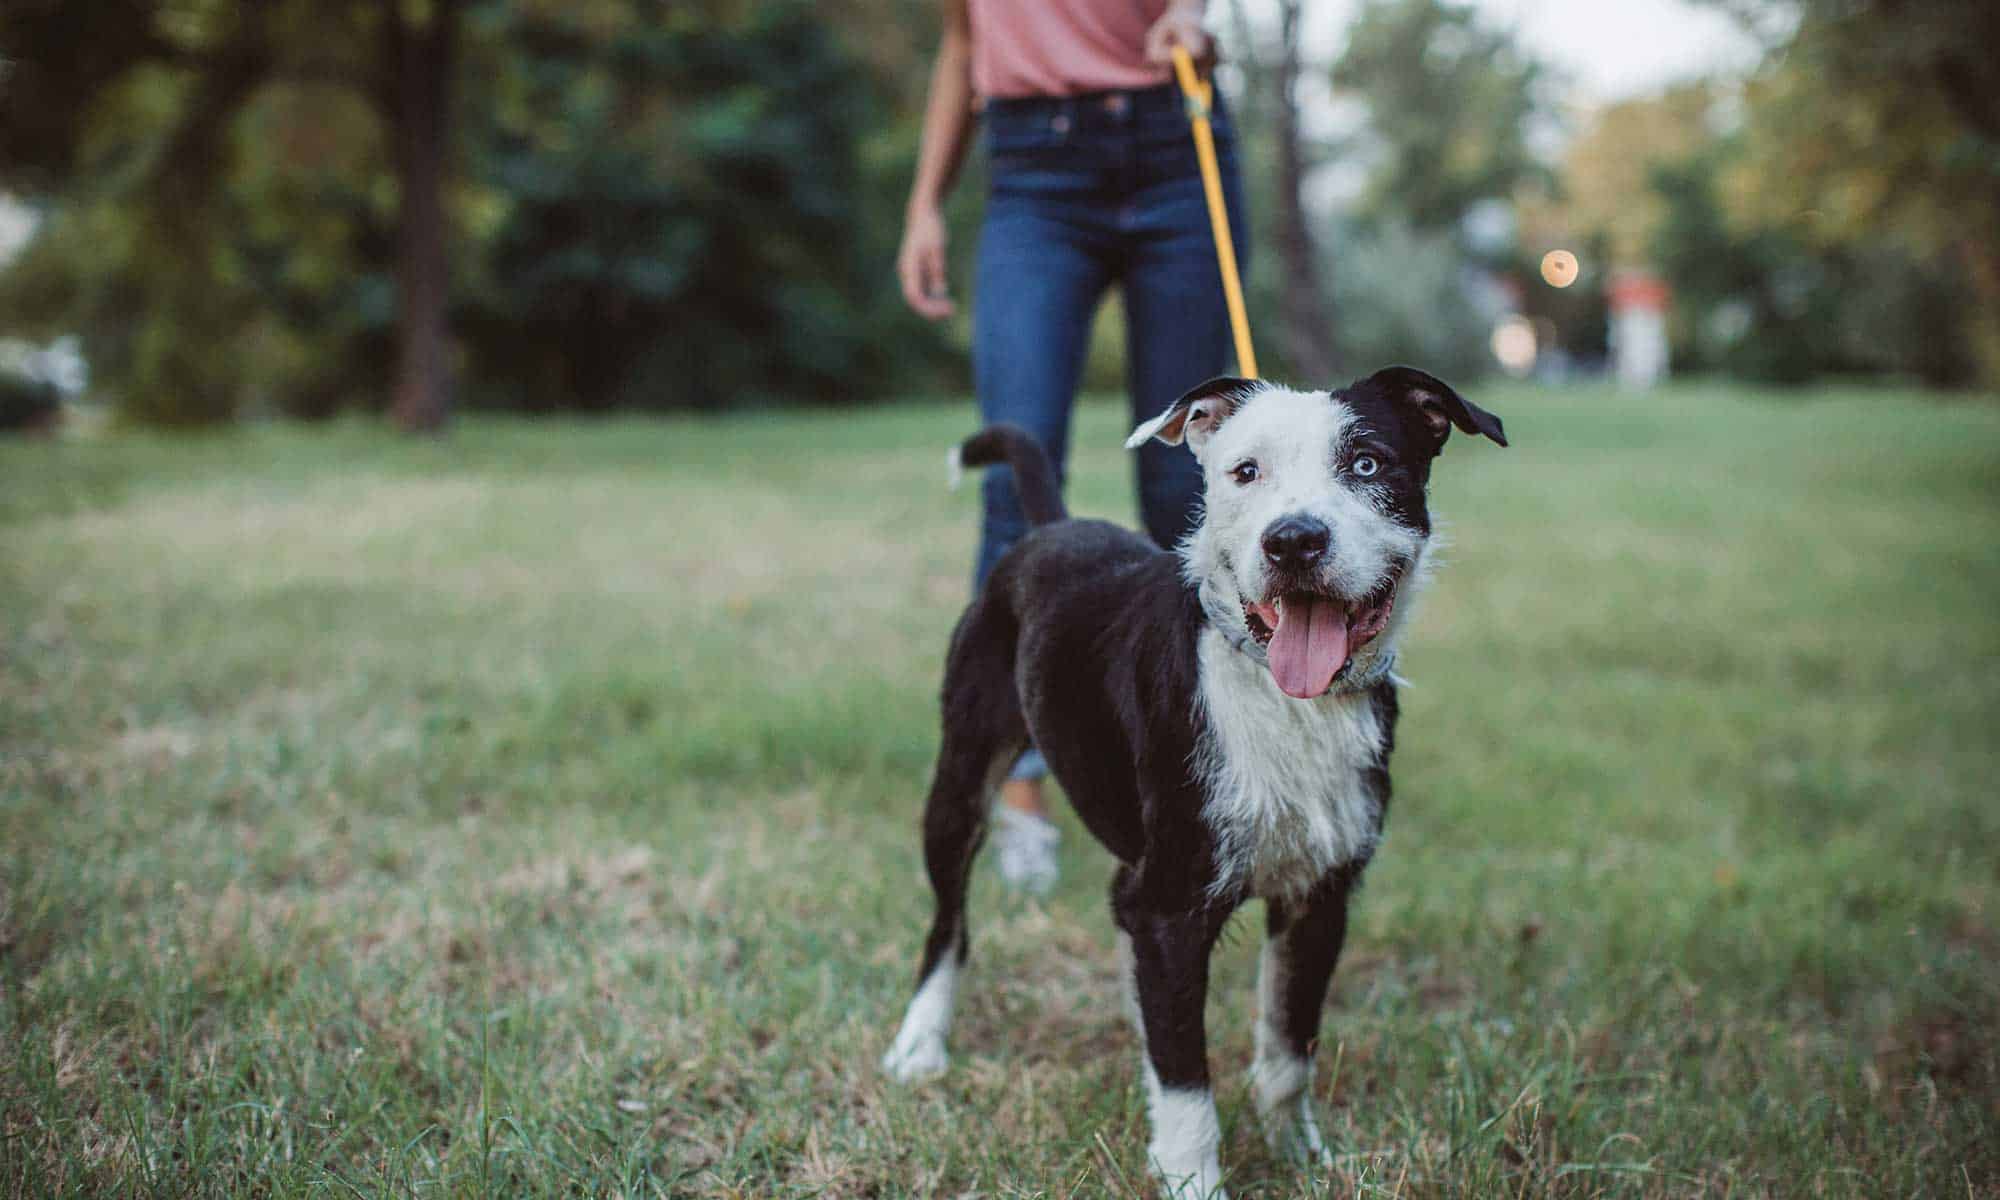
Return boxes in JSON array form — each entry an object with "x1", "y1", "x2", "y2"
[{"x1": 0, "y1": 0, "x2": 432, "y2": 424}]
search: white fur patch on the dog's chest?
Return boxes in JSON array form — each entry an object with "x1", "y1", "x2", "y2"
[{"x1": 1196, "y1": 630, "x2": 1382, "y2": 896}]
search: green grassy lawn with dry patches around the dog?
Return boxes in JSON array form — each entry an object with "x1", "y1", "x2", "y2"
[{"x1": 0, "y1": 386, "x2": 2000, "y2": 1196}]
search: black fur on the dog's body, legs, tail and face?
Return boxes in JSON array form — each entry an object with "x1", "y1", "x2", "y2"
[{"x1": 918, "y1": 368, "x2": 1504, "y2": 1176}]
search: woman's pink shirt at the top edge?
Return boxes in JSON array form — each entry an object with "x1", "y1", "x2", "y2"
[{"x1": 966, "y1": 0, "x2": 1174, "y2": 98}]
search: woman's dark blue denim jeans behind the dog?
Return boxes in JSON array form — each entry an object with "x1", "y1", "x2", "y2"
[{"x1": 972, "y1": 84, "x2": 1248, "y2": 778}]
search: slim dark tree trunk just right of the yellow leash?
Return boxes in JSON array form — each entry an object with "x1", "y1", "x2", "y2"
[{"x1": 1272, "y1": 0, "x2": 1340, "y2": 386}]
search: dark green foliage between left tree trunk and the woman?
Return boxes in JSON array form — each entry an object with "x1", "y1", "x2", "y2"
[{"x1": 464, "y1": 4, "x2": 930, "y2": 410}]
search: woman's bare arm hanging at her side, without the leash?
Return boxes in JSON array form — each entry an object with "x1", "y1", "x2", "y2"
[{"x1": 896, "y1": 0, "x2": 972, "y2": 320}]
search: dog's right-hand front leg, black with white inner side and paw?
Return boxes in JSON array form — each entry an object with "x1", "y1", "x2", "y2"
[{"x1": 1250, "y1": 872, "x2": 1354, "y2": 1166}]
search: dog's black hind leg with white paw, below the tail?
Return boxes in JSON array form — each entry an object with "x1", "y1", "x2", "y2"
[{"x1": 882, "y1": 606, "x2": 1028, "y2": 1082}]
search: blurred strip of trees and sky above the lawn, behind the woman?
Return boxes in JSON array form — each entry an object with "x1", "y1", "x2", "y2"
[{"x1": 0, "y1": 0, "x2": 2000, "y2": 428}]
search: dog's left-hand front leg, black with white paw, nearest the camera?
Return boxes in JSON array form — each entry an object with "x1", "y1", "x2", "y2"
[{"x1": 1118, "y1": 902, "x2": 1228, "y2": 1200}]
